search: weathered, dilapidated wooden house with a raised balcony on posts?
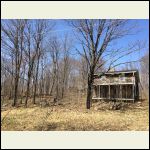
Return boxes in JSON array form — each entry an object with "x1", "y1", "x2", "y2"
[{"x1": 92, "y1": 70, "x2": 139, "y2": 102}]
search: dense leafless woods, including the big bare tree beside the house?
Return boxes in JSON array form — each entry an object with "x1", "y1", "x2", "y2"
[{"x1": 1, "y1": 19, "x2": 149, "y2": 109}]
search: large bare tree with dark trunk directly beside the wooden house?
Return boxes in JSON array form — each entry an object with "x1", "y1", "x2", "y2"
[{"x1": 69, "y1": 19, "x2": 138, "y2": 109}]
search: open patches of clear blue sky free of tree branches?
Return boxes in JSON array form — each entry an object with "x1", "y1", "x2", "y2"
[{"x1": 53, "y1": 19, "x2": 149, "y2": 69}]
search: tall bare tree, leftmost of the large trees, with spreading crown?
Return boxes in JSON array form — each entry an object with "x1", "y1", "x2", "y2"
[{"x1": 1, "y1": 20, "x2": 27, "y2": 106}]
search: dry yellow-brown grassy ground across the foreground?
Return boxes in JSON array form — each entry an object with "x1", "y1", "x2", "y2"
[{"x1": 1, "y1": 95, "x2": 149, "y2": 131}]
